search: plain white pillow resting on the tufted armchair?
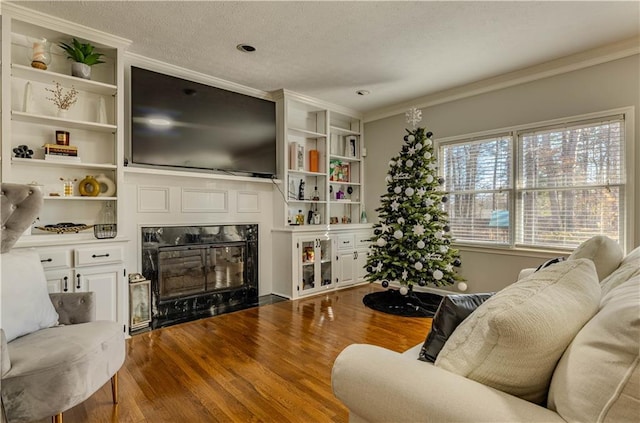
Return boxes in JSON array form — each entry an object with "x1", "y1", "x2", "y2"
[{"x1": 0, "y1": 250, "x2": 58, "y2": 342}]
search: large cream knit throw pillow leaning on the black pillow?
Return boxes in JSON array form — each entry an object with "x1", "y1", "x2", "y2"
[{"x1": 435, "y1": 259, "x2": 600, "y2": 404}]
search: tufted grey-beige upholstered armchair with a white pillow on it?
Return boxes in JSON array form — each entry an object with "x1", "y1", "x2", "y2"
[{"x1": 0, "y1": 183, "x2": 125, "y2": 423}]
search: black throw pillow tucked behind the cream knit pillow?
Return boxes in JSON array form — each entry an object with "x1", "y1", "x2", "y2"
[{"x1": 418, "y1": 293, "x2": 493, "y2": 363}]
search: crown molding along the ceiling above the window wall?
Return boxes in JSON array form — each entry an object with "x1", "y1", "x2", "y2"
[{"x1": 364, "y1": 38, "x2": 640, "y2": 123}]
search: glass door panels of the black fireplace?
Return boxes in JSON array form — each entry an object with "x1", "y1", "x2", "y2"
[{"x1": 158, "y1": 243, "x2": 245, "y2": 301}]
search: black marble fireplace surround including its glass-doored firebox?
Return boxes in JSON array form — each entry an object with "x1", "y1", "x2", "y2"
[{"x1": 142, "y1": 225, "x2": 258, "y2": 329}]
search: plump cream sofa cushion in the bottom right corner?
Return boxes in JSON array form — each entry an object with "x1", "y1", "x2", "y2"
[{"x1": 548, "y1": 275, "x2": 640, "y2": 422}]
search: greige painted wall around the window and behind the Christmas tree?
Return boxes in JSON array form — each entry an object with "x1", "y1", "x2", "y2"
[{"x1": 364, "y1": 55, "x2": 640, "y2": 292}]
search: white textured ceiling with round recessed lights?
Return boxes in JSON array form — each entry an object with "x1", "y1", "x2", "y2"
[{"x1": 14, "y1": 1, "x2": 640, "y2": 112}]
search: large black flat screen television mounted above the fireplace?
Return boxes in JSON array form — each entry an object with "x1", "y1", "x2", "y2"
[{"x1": 128, "y1": 66, "x2": 276, "y2": 177}]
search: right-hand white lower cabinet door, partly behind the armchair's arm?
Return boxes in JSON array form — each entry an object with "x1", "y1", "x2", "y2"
[{"x1": 74, "y1": 266, "x2": 123, "y2": 321}]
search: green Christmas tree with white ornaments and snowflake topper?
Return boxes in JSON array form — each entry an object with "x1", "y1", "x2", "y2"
[{"x1": 366, "y1": 109, "x2": 462, "y2": 294}]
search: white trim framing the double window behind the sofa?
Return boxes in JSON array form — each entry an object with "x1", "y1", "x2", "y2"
[{"x1": 434, "y1": 106, "x2": 636, "y2": 252}]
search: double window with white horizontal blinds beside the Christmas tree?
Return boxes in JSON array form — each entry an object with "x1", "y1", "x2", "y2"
[{"x1": 439, "y1": 115, "x2": 625, "y2": 252}]
